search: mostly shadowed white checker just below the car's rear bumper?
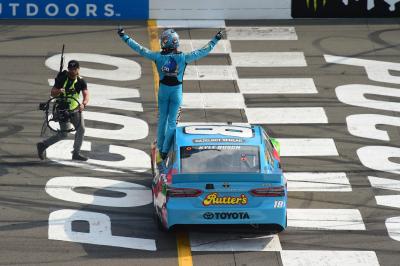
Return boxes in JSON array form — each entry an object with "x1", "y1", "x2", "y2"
[{"x1": 190, "y1": 233, "x2": 282, "y2": 252}]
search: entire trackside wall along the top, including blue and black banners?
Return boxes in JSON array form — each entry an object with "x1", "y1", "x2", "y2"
[{"x1": 0, "y1": 0, "x2": 400, "y2": 20}]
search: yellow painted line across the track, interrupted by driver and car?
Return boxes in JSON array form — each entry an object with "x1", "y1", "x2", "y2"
[{"x1": 147, "y1": 20, "x2": 193, "y2": 266}]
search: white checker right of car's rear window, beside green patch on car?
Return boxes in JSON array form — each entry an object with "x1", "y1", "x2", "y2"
[{"x1": 277, "y1": 138, "x2": 339, "y2": 156}]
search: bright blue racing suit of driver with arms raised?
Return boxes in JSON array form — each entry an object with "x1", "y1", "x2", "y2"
[{"x1": 121, "y1": 34, "x2": 218, "y2": 153}]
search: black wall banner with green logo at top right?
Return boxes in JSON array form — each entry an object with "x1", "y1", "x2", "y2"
[{"x1": 292, "y1": 0, "x2": 400, "y2": 18}]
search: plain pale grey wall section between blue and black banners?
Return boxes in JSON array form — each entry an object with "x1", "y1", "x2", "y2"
[{"x1": 149, "y1": 0, "x2": 292, "y2": 19}]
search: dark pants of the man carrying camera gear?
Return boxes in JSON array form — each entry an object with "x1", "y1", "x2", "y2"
[{"x1": 43, "y1": 113, "x2": 85, "y2": 153}]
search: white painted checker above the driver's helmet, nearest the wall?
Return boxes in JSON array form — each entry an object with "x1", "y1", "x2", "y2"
[{"x1": 157, "y1": 19, "x2": 225, "y2": 29}]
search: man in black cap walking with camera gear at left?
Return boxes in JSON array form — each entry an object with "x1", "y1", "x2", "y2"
[{"x1": 36, "y1": 60, "x2": 89, "y2": 161}]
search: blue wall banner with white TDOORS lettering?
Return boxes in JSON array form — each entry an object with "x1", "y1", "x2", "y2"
[{"x1": 0, "y1": 0, "x2": 149, "y2": 19}]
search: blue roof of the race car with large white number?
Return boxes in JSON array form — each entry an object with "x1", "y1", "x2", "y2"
[{"x1": 176, "y1": 124, "x2": 262, "y2": 146}]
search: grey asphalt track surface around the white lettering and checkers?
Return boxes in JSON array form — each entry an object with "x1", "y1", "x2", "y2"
[{"x1": 0, "y1": 19, "x2": 400, "y2": 266}]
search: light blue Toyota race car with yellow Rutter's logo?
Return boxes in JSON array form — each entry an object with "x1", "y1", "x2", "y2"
[{"x1": 151, "y1": 124, "x2": 287, "y2": 232}]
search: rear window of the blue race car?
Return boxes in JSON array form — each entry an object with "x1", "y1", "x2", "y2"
[{"x1": 180, "y1": 145, "x2": 260, "y2": 173}]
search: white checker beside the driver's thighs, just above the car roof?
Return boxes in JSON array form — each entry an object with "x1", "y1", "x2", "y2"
[{"x1": 182, "y1": 93, "x2": 246, "y2": 109}]
